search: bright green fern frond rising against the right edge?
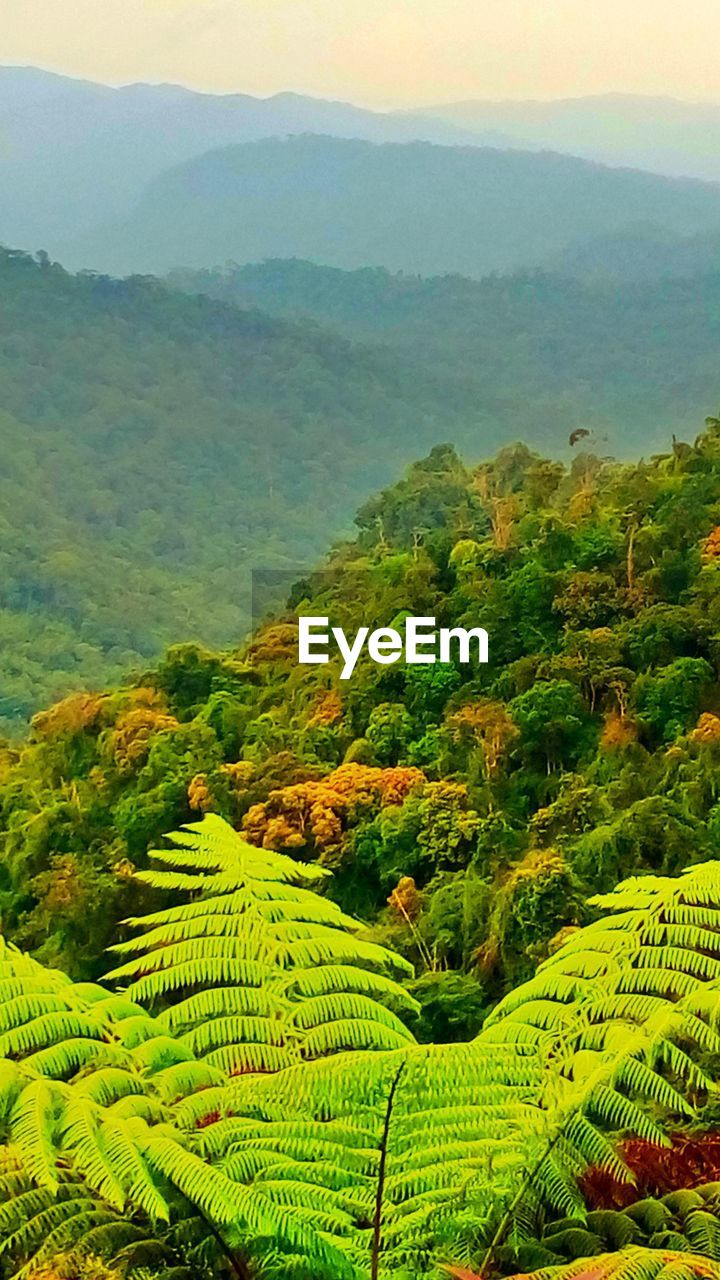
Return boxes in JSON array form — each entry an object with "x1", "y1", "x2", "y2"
[{"x1": 480, "y1": 863, "x2": 720, "y2": 1142}]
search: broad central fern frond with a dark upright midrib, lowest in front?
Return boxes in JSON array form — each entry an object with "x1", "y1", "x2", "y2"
[{"x1": 172, "y1": 1044, "x2": 550, "y2": 1280}]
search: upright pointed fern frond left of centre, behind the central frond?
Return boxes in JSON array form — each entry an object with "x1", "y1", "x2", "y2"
[{"x1": 108, "y1": 815, "x2": 416, "y2": 1075}]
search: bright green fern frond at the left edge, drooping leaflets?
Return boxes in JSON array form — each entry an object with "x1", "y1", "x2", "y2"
[{"x1": 0, "y1": 940, "x2": 204, "y2": 1264}]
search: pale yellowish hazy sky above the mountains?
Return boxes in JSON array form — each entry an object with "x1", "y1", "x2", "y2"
[{"x1": 0, "y1": 0, "x2": 720, "y2": 105}]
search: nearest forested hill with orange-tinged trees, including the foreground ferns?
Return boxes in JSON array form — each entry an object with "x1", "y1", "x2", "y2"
[{"x1": 0, "y1": 420, "x2": 720, "y2": 1280}]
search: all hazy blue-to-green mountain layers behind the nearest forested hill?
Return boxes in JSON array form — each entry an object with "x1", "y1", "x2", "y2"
[{"x1": 0, "y1": 68, "x2": 720, "y2": 731}]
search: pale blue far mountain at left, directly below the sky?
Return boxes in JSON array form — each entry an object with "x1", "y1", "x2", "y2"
[{"x1": 0, "y1": 67, "x2": 489, "y2": 250}]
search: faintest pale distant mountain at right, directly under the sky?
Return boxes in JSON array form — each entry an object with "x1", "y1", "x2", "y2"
[{"x1": 407, "y1": 93, "x2": 720, "y2": 180}]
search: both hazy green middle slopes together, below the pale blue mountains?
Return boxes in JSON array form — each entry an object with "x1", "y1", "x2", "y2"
[{"x1": 7, "y1": 252, "x2": 720, "y2": 732}]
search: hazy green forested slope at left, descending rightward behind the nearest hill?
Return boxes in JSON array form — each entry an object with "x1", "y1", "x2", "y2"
[{"x1": 0, "y1": 252, "x2": 486, "y2": 728}]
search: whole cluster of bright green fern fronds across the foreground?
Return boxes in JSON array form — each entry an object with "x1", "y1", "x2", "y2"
[{"x1": 9, "y1": 844, "x2": 720, "y2": 1280}]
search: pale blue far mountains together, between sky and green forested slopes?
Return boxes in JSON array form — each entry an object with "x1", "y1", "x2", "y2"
[{"x1": 0, "y1": 67, "x2": 720, "y2": 276}]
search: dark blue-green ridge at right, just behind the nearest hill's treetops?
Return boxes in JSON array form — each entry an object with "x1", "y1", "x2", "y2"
[{"x1": 172, "y1": 252, "x2": 720, "y2": 457}]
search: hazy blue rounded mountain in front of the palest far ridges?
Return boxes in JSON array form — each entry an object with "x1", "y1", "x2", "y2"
[{"x1": 61, "y1": 136, "x2": 720, "y2": 278}]
